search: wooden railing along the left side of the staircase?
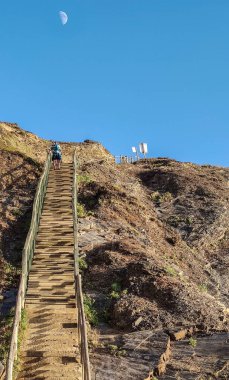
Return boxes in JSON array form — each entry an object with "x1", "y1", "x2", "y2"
[{"x1": 6, "y1": 154, "x2": 51, "y2": 380}]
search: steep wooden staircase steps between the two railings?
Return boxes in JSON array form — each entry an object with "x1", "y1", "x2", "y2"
[{"x1": 17, "y1": 164, "x2": 82, "y2": 380}]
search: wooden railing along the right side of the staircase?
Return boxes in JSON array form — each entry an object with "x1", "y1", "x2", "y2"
[{"x1": 72, "y1": 151, "x2": 91, "y2": 380}]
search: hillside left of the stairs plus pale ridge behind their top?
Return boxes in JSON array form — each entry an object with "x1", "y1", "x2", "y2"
[{"x1": 0, "y1": 122, "x2": 112, "y2": 372}]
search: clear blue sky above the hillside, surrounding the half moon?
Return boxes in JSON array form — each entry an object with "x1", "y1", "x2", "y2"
[{"x1": 0, "y1": 0, "x2": 229, "y2": 166}]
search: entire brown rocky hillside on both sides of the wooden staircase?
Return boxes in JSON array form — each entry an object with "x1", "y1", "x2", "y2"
[{"x1": 0, "y1": 123, "x2": 229, "y2": 380}]
